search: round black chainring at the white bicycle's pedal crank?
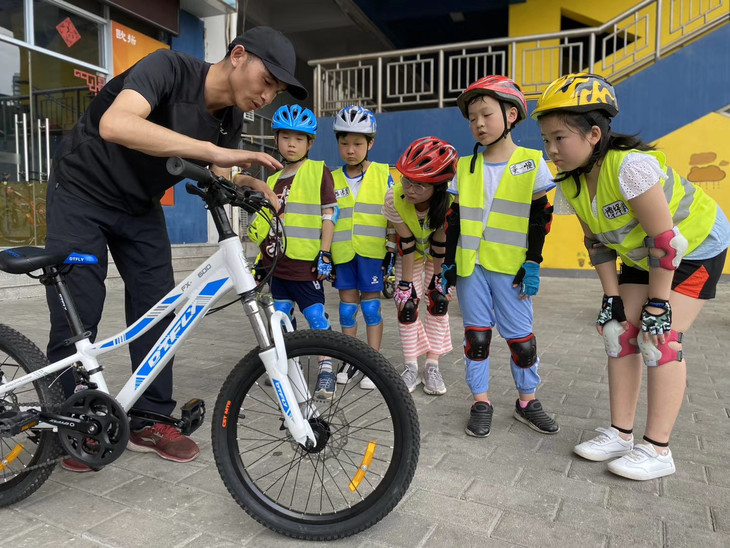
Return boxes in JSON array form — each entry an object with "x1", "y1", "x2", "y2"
[{"x1": 58, "y1": 390, "x2": 129, "y2": 468}]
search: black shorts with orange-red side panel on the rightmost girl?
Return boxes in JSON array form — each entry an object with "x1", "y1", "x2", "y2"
[{"x1": 618, "y1": 249, "x2": 727, "y2": 299}]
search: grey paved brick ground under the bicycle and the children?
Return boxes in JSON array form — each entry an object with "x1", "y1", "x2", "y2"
[{"x1": 0, "y1": 277, "x2": 730, "y2": 548}]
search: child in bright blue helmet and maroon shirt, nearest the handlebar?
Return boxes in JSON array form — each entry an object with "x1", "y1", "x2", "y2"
[{"x1": 249, "y1": 105, "x2": 337, "y2": 399}]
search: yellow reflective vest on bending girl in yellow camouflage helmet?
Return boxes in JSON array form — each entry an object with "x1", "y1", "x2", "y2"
[{"x1": 561, "y1": 150, "x2": 717, "y2": 270}]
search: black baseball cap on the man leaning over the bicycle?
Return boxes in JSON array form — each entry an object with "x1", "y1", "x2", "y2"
[{"x1": 227, "y1": 27, "x2": 309, "y2": 99}]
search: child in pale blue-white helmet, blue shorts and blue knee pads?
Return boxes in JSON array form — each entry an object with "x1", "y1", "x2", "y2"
[{"x1": 332, "y1": 106, "x2": 396, "y2": 390}]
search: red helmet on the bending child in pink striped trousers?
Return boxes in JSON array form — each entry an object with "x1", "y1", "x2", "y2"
[{"x1": 395, "y1": 137, "x2": 459, "y2": 184}]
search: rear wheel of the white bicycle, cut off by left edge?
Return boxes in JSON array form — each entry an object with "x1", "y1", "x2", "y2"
[{"x1": 0, "y1": 325, "x2": 64, "y2": 507}]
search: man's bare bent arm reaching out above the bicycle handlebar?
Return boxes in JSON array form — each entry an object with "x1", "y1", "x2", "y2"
[{"x1": 99, "y1": 89, "x2": 282, "y2": 170}]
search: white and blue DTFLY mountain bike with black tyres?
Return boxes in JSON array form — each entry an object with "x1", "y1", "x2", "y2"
[{"x1": 0, "y1": 158, "x2": 420, "y2": 540}]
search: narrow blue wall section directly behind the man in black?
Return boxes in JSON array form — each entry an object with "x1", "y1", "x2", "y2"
[{"x1": 163, "y1": 10, "x2": 203, "y2": 244}]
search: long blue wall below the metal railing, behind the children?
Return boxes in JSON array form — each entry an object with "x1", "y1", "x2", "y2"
[{"x1": 310, "y1": 24, "x2": 730, "y2": 167}]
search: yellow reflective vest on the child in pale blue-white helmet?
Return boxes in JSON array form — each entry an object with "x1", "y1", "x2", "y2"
[{"x1": 332, "y1": 162, "x2": 390, "y2": 264}]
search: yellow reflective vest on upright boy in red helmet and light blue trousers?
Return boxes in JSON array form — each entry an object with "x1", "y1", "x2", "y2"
[{"x1": 456, "y1": 147, "x2": 542, "y2": 277}]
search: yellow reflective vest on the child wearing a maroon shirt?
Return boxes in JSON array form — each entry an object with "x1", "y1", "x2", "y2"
[{"x1": 248, "y1": 160, "x2": 324, "y2": 261}]
